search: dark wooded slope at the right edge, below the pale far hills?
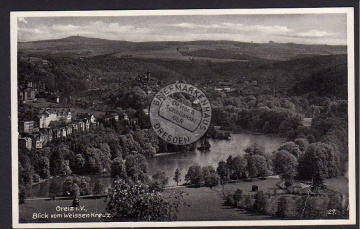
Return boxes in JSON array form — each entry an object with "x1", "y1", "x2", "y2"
[{"x1": 246, "y1": 55, "x2": 347, "y2": 99}]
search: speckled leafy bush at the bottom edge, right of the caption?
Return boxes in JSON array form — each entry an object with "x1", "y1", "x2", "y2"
[{"x1": 105, "y1": 177, "x2": 185, "y2": 221}]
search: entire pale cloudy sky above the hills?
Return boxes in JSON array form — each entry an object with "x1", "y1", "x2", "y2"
[{"x1": 17, "y1": 13, "x2": 347, "y2": 45}]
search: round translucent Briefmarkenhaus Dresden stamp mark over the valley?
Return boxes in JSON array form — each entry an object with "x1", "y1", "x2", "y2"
[{"x1": 149, "y1": 83, "x2": 211, "y2": 145}]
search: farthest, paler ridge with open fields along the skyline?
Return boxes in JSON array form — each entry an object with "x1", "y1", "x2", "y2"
[{"x1": 18, "y1": 36, "x2": 346, "y2": 62}]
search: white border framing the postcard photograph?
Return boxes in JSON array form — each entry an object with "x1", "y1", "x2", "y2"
[{"x1": 10, "y1": 7, "x2": 357, "y2": 228}]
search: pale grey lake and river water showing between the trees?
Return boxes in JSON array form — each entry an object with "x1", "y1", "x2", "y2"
[{"x1": 28, "y1": 134, "x2": 285, "y2": 197}]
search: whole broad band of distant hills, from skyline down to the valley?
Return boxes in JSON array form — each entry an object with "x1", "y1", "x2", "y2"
[{"x1": 18, "y1": 37, "x2": 347, "y2": 99}]
